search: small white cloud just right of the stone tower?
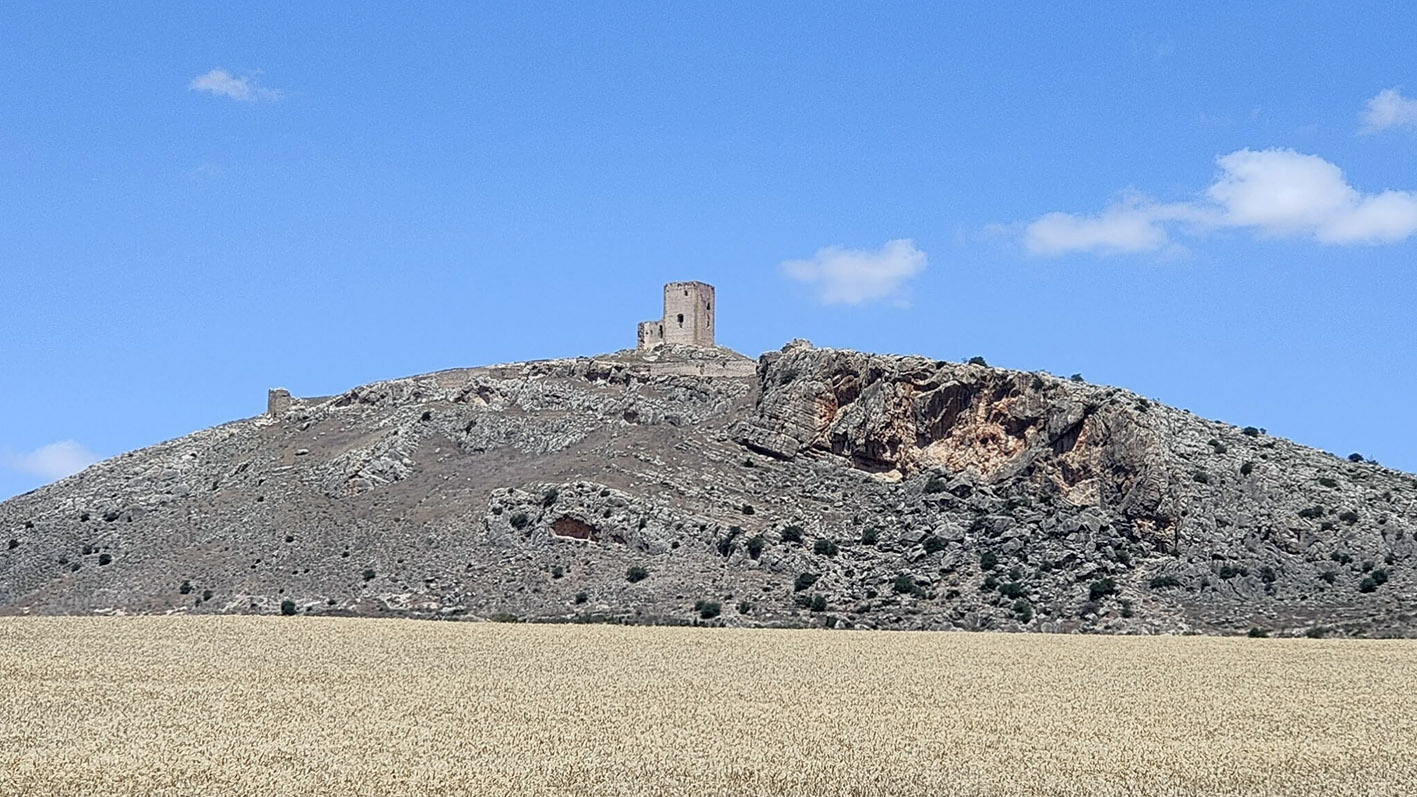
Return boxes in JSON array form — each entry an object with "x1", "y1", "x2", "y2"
[{"x1": 782, "y1": 238, "x2": 927, "y2": 305}]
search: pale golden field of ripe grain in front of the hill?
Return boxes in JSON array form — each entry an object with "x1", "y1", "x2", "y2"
[{"x1": 0, "y1": 617, "x2": 1417, "y2": 797}]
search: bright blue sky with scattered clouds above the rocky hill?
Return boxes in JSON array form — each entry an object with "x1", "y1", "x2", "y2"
[{"x1": 0, "y1": 3, "x2": 1417, "y2": 496}]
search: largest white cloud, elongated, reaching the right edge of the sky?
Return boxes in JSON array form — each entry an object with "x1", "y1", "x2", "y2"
[{"x1": 1020, "y1": 149, "x2": 1417, "y2": 257}]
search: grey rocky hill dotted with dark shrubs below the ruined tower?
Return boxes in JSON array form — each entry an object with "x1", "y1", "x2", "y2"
[{"x1": 0, "y1": 342, "x2": 1417, "y2": 635}]
